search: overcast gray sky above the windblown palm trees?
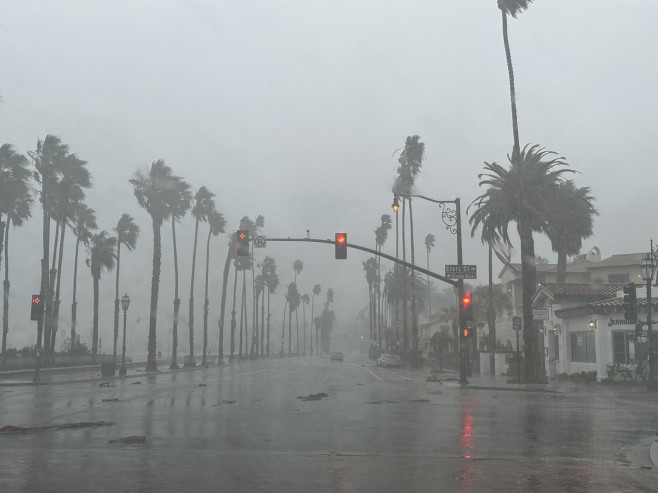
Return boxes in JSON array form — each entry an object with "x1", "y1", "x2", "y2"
[{"x1": 0, "y1": 0, "x2": 658, "y2": 350}]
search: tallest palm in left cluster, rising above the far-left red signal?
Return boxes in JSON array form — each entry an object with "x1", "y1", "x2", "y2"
[{"x1": 28, "y1": 134, "x2": 69, "y2": 358}]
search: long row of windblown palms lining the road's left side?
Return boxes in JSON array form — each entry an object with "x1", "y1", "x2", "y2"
[{"x1": 0, "y1": 139, "x2": 333, "y2": 370}]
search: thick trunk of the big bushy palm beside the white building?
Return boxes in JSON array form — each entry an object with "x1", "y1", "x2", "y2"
[{"x1": 517, "y1": 223, "x2": 539, "y2": 382}]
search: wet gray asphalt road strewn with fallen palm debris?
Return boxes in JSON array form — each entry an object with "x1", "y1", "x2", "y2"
[{"x1": 0, "y1": 357, "x2": 658, "y2": 492}]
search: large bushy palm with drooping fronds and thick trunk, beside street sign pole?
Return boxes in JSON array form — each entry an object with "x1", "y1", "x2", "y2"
[{"x1": 469, "y1": 145, "x2": 573, "y2": 381}]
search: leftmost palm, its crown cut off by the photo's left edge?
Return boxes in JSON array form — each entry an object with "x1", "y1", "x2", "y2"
[{"x1": 0, "y1": 144, "x2": 33, "y2": 367}]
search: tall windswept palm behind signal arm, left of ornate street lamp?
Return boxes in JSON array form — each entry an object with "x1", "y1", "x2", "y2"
[{"x1": 393, "y1": 135, "x2": 425, "y2": 356}]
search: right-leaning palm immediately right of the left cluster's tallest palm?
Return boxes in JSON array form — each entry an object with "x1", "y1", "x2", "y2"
[{"x1": 50, "y1": 154, "x2": 91, "y2": 354}]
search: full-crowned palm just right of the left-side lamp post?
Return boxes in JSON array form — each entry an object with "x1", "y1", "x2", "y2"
[{"x1": 130, "y1": 159, "x2": 179, "y2": 371}]
